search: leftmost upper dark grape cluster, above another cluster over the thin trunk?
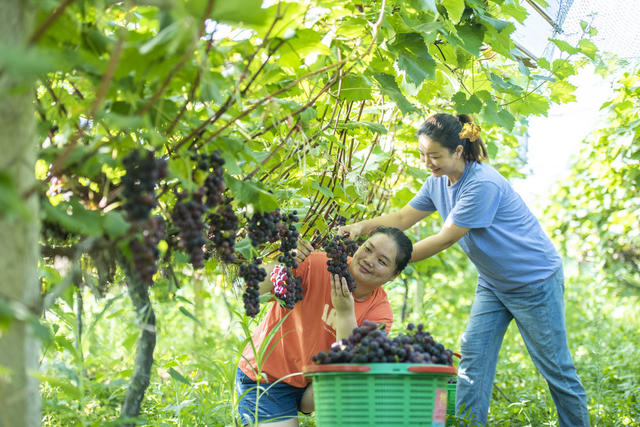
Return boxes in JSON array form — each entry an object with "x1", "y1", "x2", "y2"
[{"x1": 122, "y1": 150, "x2": 168, "y2": 221}]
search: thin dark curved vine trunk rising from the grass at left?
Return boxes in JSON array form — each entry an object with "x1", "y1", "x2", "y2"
[{"x1": 120, "y1": 259, "x2": 156, "y2": 426}]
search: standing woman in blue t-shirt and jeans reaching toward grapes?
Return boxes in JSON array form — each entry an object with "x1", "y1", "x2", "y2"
[{"x1": 339, "y1": 114, "x2": 589, "y2": 427}]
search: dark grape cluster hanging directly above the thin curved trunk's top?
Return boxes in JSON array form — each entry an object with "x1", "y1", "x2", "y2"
[{"x1": 129, "y1": 216, "x2": 166, "y2": 286}]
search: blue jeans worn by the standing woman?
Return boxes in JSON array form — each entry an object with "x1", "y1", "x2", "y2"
[{"x1": 456, "y1": 267, "x2": 589, "y2": 427}]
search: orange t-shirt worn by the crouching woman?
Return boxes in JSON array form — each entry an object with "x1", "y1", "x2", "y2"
[{"x1": 238, "y1": 252, "x2": 393, "y2": 387}]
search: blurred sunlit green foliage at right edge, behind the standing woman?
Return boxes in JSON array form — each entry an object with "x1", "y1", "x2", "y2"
[{"x1": 546, "y1": 71, "x2": 640, "y2": 294}]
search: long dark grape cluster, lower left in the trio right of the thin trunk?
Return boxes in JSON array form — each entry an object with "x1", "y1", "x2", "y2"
[{"x1": 171, "y1": 191, "x2": 206, "y2": 268}]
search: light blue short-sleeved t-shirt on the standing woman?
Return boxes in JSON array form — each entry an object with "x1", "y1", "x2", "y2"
[{"x1": 409, "y1": 162, "x2": 562, "y2": 292}]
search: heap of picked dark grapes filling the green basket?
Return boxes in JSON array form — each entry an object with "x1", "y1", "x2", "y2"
[{"x1": 311, "y1": 320, "x2": 453, "y2": 365}]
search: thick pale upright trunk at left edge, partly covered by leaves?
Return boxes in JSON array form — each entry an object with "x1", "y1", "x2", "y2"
[{"x1": 0, "y1": 1, "x2": 41, "y2": 427}]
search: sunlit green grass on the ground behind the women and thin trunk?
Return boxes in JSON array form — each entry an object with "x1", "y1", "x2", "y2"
[{"x1": 41, "y1": 266, "x2": 640, "y2": 427}]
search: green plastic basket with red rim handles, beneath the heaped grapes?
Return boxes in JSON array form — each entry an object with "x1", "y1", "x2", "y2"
[{"x1": 303, "y1": 363, "x2": 456, "y2": 427}]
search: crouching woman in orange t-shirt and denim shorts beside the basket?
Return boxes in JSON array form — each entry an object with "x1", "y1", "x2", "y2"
[{"x1": 236, "y1": 227, "x2": 413, "y2": 427}]
